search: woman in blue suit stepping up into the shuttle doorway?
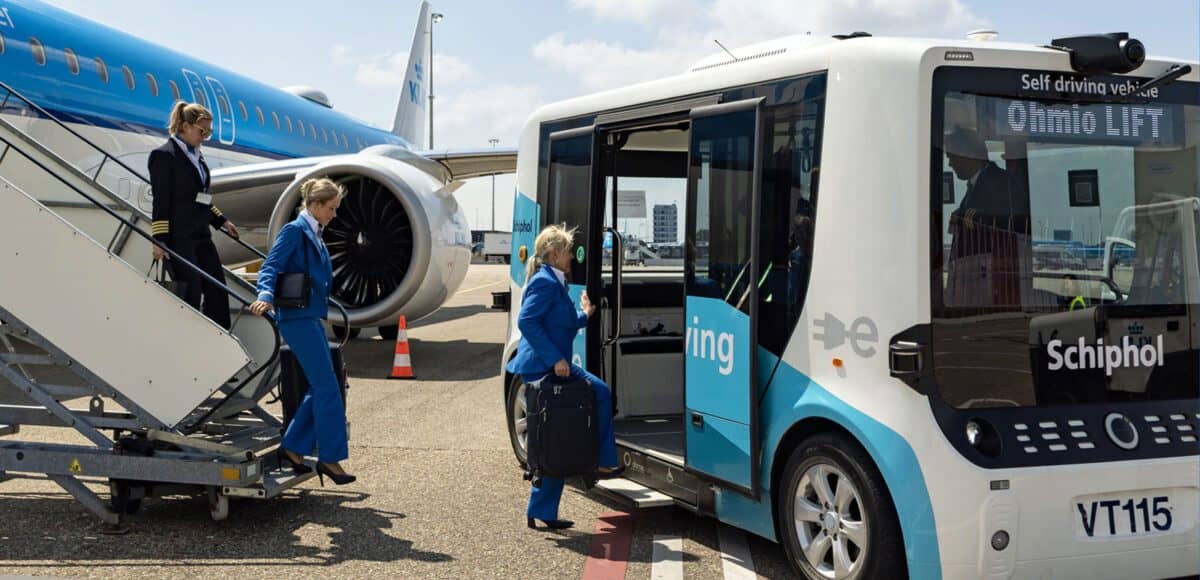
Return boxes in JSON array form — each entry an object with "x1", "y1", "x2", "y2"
[{"x1": 508, "y1": 226, "x2": 624, "y2": 530}]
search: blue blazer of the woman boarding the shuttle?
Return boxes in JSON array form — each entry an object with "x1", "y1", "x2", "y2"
[{"x1": 506, "y1": 264, "x2": 588, "y2": 376}]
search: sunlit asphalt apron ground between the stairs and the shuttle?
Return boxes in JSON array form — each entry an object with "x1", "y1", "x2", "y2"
[{"x1": 7, "y1": 264, "x2": 806, "y2": 579}]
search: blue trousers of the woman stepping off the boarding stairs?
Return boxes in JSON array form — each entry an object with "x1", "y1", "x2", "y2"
[{"x1": 280, "y1": 318, "x2": 350, "y2": 464}]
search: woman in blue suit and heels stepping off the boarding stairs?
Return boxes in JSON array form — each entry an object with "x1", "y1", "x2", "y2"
[{"x1": 250, "y1": 178, "x2": 355, "y2": 485}]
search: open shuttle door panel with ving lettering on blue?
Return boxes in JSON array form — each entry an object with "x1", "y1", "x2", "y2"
[{"x1": 684, "y1": 98, "x2": 763, "y2": 497}]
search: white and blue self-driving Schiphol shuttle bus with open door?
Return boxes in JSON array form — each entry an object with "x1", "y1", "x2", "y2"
[{"x1": 502, "y1": 34, "x2": 1200, "y2": 580}]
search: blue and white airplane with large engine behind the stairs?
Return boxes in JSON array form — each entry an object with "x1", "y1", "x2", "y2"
[{"x1": 0, "y1": 0, "x2": 516, "y2": 337}]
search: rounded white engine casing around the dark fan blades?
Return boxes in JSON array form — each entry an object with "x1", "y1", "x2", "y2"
[{"x1": 268, "y1": 148, "x2": 470, "y2": 327}]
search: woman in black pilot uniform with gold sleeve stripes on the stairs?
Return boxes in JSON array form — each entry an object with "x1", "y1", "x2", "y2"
[{"x1": 149, "y1": 101, "x2": 238, "y2": 328}]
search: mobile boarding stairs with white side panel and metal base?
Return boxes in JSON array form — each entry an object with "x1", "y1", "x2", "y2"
[{"x1": 0, "y1": 83, "x2": 324, "y2": 532}]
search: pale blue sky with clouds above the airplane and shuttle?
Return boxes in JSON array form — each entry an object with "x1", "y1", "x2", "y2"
[{"x1": 44, "y1": 0, "x2": 1200, "y2": 229}]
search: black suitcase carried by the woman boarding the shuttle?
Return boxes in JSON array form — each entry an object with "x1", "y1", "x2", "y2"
[{"x1": 526, "y1": 375, "x2": 600, "y2": 482}]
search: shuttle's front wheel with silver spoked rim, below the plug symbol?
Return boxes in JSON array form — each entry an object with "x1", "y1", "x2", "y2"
[{"x1": 775, "y1": 433, "x2": 908, "y2": 580}]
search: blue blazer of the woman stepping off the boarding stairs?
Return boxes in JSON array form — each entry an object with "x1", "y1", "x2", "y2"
[{"x1": 258, "y1": 216, "x2": 334, "y2": 322}]
